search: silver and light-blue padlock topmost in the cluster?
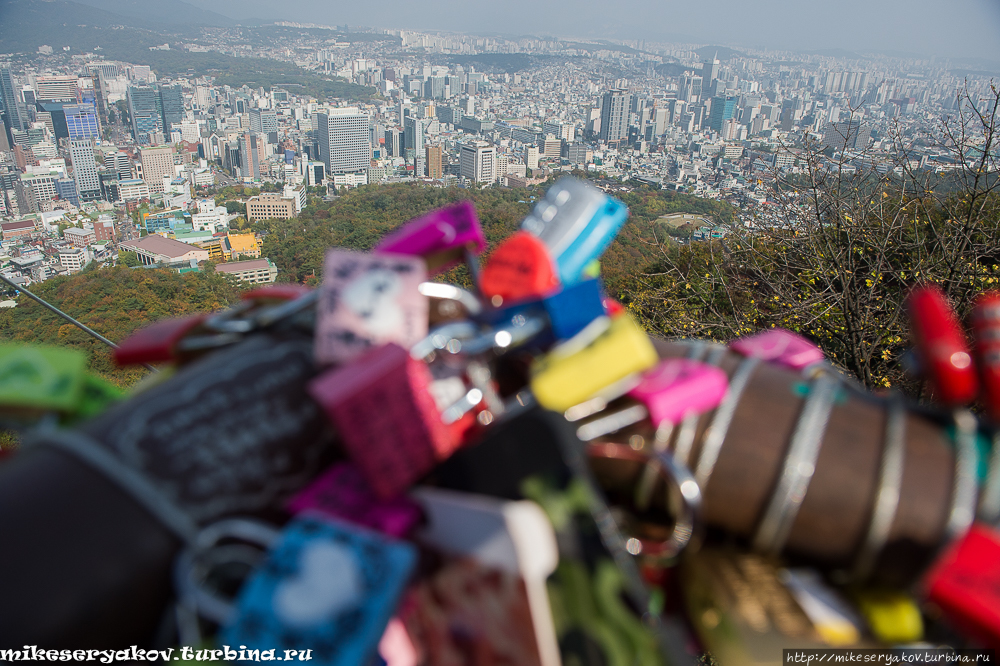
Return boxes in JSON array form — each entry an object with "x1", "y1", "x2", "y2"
[{"x1": 521, "y1": 177, "x2": 628, "y2": 286}]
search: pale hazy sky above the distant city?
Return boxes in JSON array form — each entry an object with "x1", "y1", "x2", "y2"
[{"x1": 187, "y1": 0, "x2": 1000, "y2": 63}]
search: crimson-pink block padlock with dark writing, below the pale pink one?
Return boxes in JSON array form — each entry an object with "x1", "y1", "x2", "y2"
[{"x1": 309, "y1": 343, "x2": 483, "y2": 499}]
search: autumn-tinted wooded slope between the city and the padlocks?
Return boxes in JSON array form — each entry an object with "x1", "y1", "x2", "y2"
[{"x1": 0, "y1": 184, "x2": 731, "y2": 386}]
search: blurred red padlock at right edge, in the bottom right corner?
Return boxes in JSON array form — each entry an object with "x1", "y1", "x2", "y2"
[{"x1": 924, "y1": 523, "x2": 1000, "y2": 649}]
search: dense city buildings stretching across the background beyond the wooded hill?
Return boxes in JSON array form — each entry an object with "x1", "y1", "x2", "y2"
[{"x1": 0, "y1": 17, "x2": 989, "y2": 282}]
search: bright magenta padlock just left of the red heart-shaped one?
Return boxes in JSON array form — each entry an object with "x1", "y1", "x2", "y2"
[{"x1": 374, "y1": 201, "x2": 486, "y2": 274}]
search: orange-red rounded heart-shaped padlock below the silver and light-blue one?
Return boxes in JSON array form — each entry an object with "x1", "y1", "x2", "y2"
[{"x1": 480, "y1": 231, "x2": 559, "y2": 306}]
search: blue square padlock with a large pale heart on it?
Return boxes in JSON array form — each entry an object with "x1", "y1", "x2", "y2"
[{"x1": 222, "y1": 516, "x2": 417, "y2": 666}]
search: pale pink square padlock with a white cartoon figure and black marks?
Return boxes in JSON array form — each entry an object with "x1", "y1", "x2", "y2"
[{"x1": 316, "y1": 248, "x2": 428, "y2": 363}]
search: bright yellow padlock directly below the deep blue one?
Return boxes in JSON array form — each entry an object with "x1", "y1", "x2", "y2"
[{"x1": 531, "y1": 313, "x2": 659, "y2": 412}]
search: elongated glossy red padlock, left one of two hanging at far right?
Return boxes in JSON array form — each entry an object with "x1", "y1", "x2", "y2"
[{"x1": 906, "y1": 284, "x2": 979, "y2": 407}]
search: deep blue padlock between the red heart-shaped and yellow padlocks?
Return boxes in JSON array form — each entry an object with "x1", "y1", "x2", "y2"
[{"x1": 483, "y1": 278, "x2": 605, "y2": 347}]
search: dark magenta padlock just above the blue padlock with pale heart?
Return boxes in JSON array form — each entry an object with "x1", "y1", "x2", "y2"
[{"x1": 287, "y1": 463, "x2": 421, "y2": 539}]
